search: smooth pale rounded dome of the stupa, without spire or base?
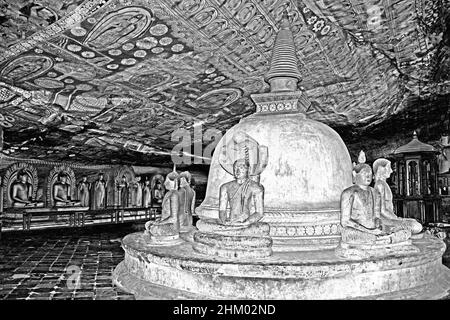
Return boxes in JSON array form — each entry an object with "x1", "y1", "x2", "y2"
[{"x1": 199, "y1": 114, "x2": 352, "y2": 221}]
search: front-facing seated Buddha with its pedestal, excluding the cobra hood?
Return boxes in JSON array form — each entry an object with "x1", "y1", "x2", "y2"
[{"x1": 193, "y1": 159, "x2": 272, "y2": 258}]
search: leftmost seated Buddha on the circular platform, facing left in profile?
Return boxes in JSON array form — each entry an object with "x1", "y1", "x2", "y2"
[{"x1": 145, "y1": 171, "x2": 182, "y2": 245}]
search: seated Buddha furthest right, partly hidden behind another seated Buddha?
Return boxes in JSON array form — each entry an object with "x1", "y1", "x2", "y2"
[{"x1": 372, "y1": 158, "x2": 423, "y2": 239}]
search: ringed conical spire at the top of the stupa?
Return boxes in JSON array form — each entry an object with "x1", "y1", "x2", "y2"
[{"x1": 265, "y1": 11, "x2": 301, "y2": 92}]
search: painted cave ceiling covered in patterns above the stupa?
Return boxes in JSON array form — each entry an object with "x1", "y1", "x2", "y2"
[{"x1": 0, "y1": 0, "x2": 450, "y2": 164}]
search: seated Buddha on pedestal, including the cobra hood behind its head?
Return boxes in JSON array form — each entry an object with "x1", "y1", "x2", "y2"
[{"x1": 193, "y1": 132, "x2": 272, "y2": 258}]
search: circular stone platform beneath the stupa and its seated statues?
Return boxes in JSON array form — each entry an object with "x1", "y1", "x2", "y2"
[{"x1": 113, "y1": 233, "x2": 450, "y2": 299}]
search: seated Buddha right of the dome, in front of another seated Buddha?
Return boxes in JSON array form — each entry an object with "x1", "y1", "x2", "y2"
[{"x1": 336, "y1": 151, "x2": 418, "y2": 258}]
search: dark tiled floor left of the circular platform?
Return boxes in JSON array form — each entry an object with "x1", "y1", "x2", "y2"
[{"x1": 0, "y1": 224, "x2": 450, "y2": 300}]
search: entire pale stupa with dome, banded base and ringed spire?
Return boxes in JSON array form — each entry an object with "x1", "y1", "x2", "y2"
[{"x1": 196, "y1": 15, "x2": 352, "y2": 250}]
